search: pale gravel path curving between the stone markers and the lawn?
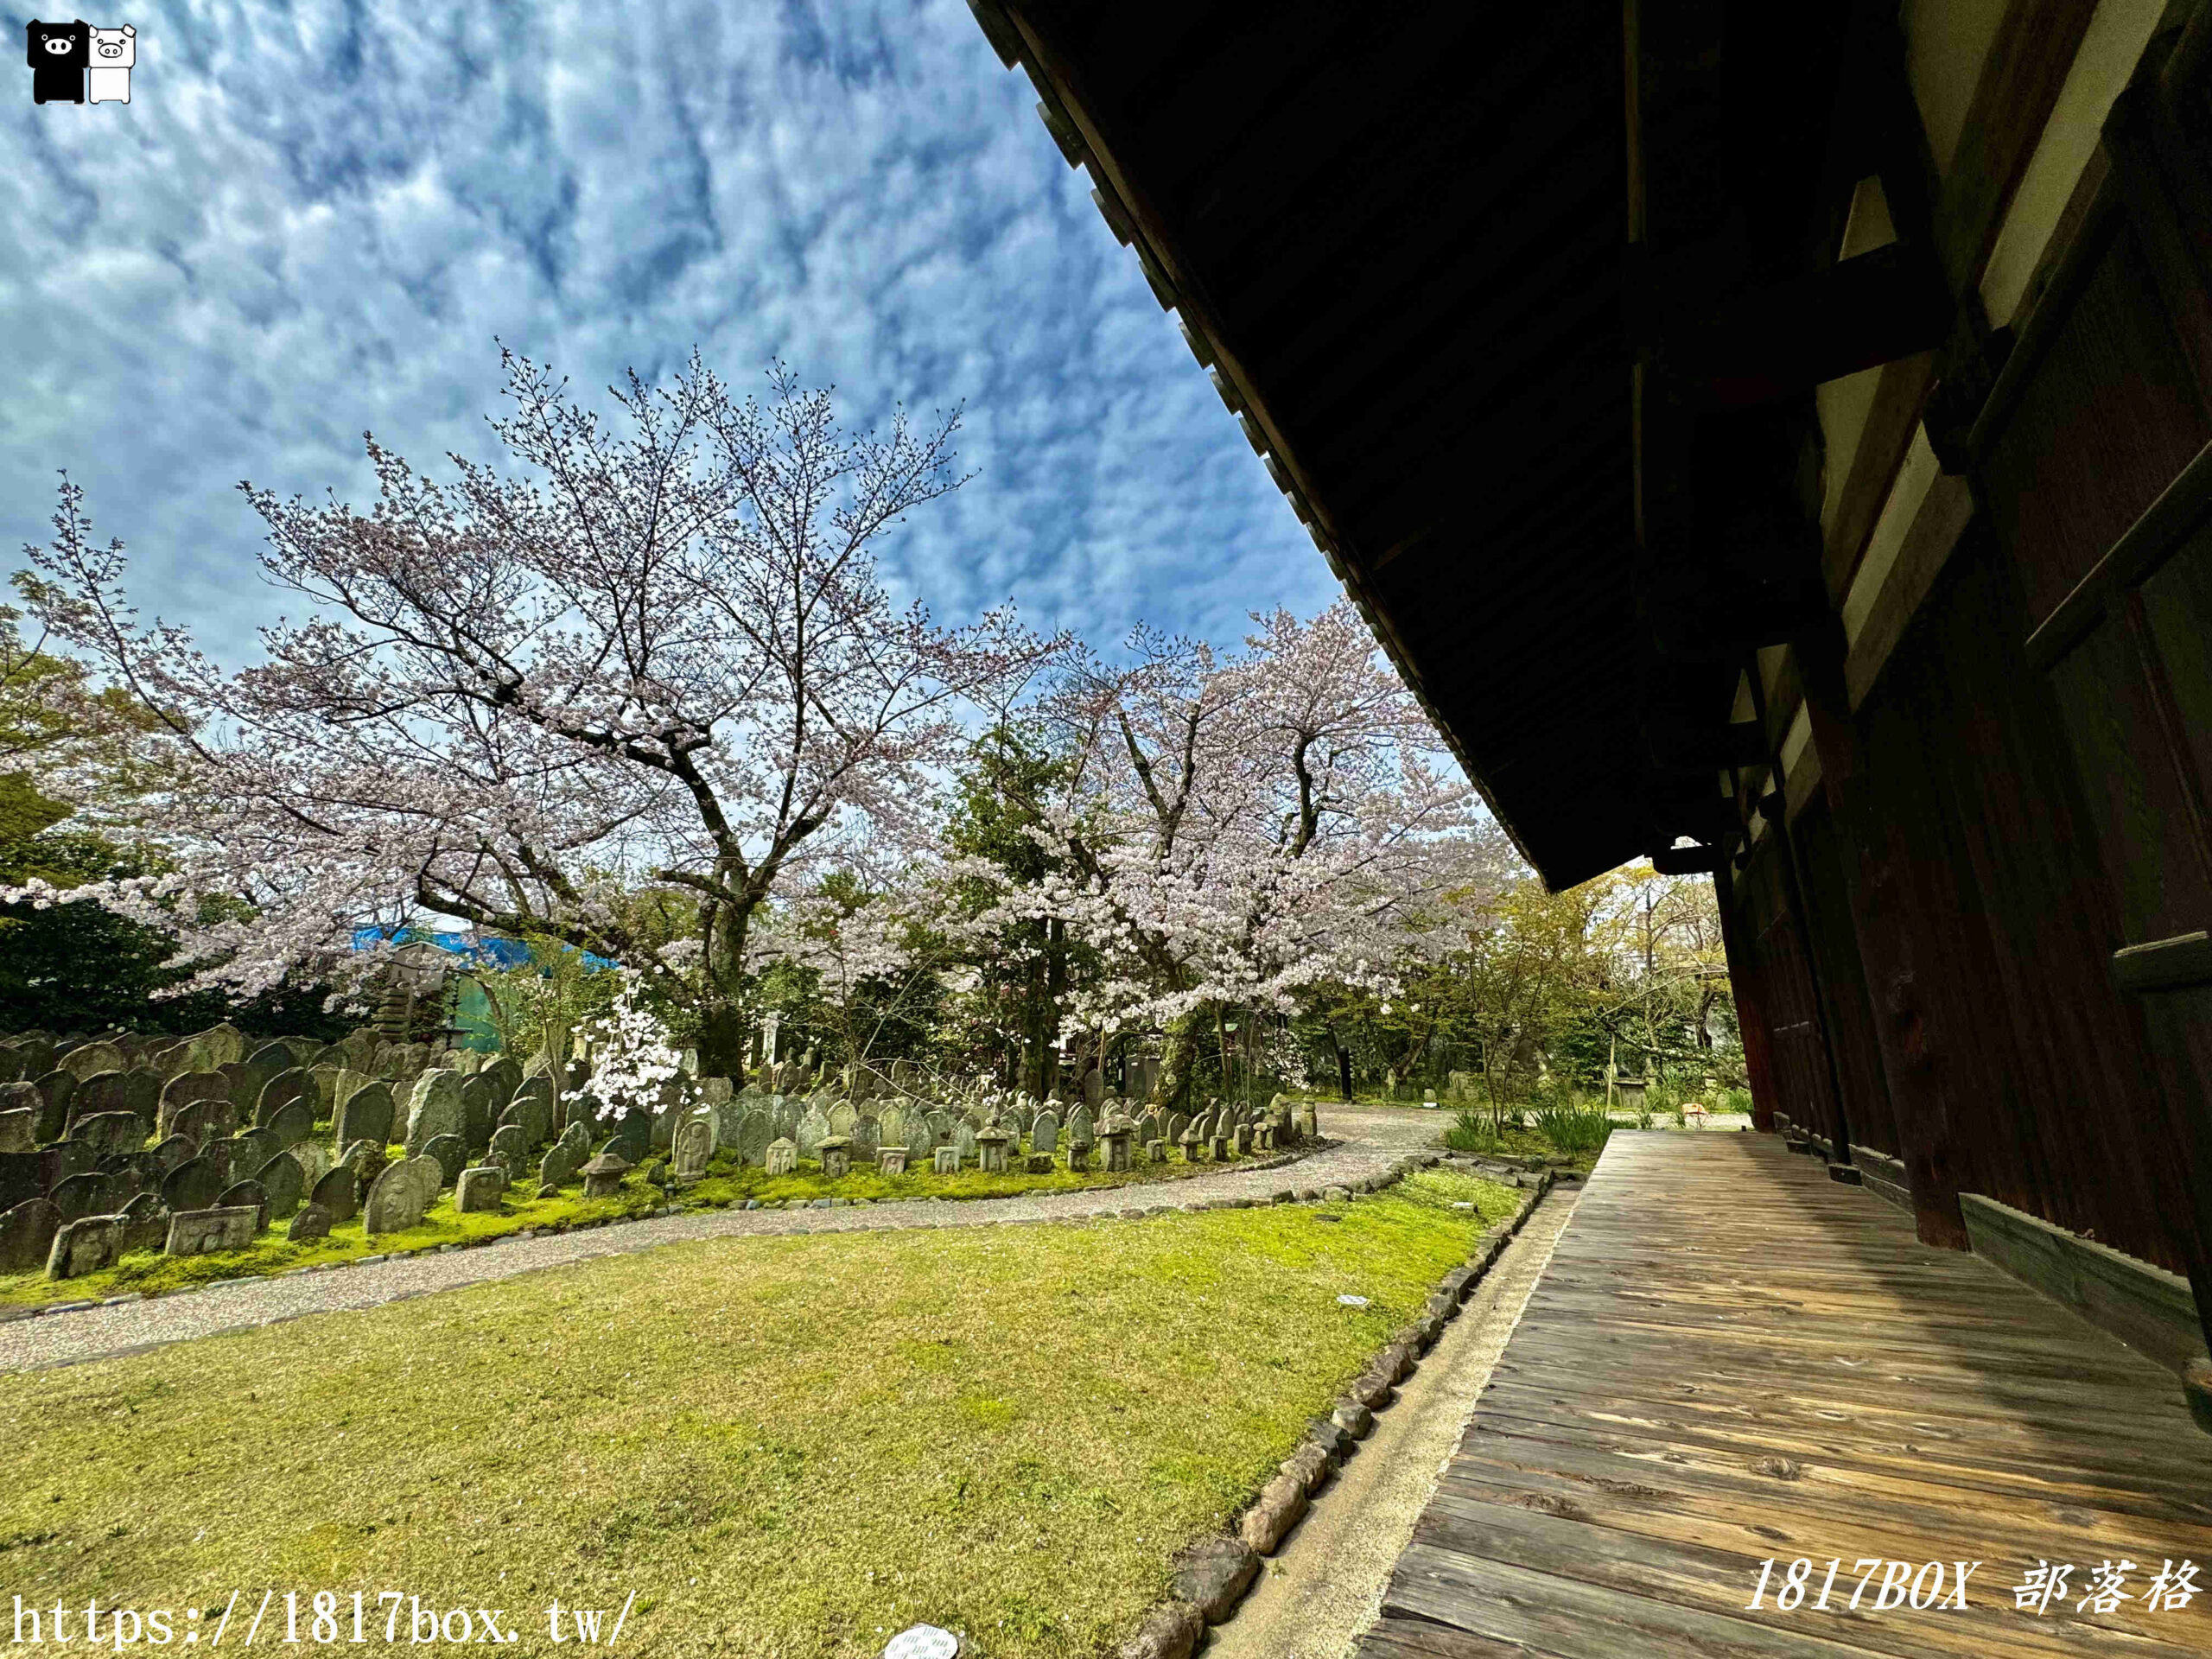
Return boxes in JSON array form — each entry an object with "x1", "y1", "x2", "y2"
[{"x1": 0, "y1": 1106, "x2": 1445, "y2": 1371}]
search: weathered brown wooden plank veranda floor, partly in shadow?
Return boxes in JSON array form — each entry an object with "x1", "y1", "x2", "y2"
[{"x1": 1358, "y1": 1130, "x2": 2212, "y2": 1659}]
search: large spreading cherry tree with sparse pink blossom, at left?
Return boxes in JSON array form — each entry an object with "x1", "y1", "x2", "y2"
[{"x1": 13, "y1": 352, "x2": 1066, "y2": 1075}]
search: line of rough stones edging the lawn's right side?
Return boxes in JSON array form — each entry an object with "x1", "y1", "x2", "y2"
[{"x1": 1117, "y1": 1153, "x2": 1553, "y2": 1659}]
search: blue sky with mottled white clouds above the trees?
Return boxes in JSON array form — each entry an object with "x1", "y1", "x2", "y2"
[{"x1": 0, "y1": 0, "x2": 1336, "y2": 661}]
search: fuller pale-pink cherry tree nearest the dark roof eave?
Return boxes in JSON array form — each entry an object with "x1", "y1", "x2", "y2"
[{"x1": 960, "y1": 604, "x2": 1506, "y2": 1099}]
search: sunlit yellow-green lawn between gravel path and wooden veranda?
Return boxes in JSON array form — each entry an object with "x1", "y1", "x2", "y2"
[{"x1": 0, "y1": 1173, "x2": 1524, "y2": 1659}]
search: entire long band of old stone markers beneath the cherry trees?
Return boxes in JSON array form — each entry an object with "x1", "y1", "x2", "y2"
[{"x1": 0, "y1": 1024, "x2": 1314, "y2": 1279}]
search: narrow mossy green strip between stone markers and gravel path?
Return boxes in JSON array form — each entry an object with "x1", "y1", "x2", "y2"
[{"x1": 0, "y1": 1146, "x2": 1247, "y2": 1307}]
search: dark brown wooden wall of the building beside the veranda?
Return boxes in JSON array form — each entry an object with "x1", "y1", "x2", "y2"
[{"x1": 1732, "y1": 22, "x2": 2212, "y2": 1336}]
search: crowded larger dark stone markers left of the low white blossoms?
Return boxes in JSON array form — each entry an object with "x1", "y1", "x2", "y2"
[{"x1": 0, "y1": 1027, "x2": 696, "y2": 1279}]
